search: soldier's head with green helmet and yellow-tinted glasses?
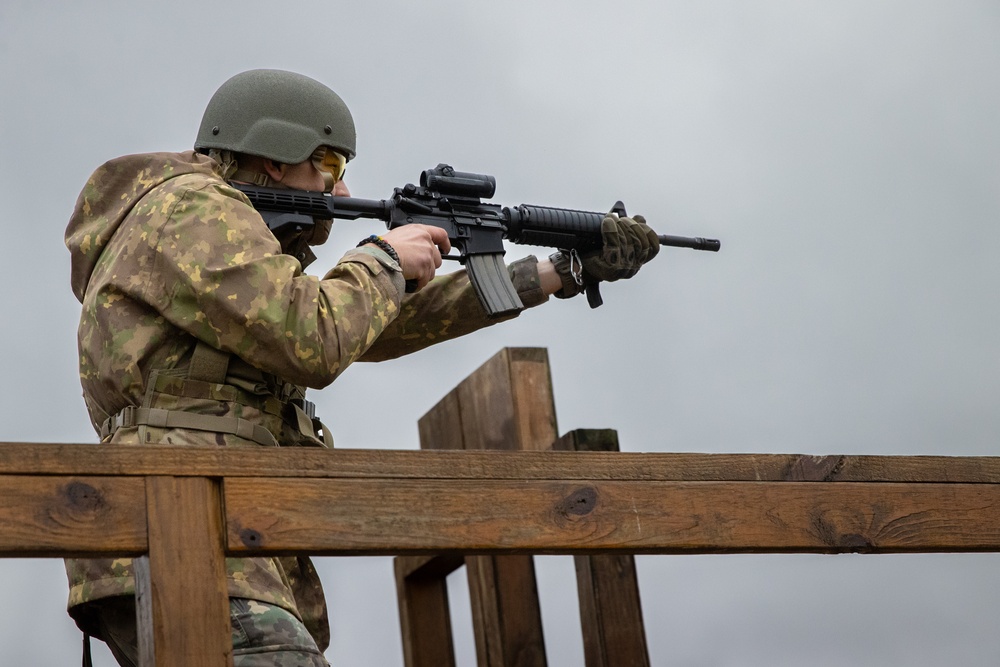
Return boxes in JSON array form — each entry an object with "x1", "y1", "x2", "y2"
[{"x1": 194, "y1": 69, "x2": 357, "y2": 194}]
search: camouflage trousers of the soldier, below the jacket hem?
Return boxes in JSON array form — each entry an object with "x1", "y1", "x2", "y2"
[{"x1": 87, "y1": 596, "x2": 330, "y2": 667}]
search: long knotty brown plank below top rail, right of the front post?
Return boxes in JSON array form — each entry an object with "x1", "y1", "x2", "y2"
[{"x1": 224, "y1": 478, "x2": 1000, "y2": 555}]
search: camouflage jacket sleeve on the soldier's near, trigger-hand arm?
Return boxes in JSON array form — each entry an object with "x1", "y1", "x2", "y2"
[{"x1": 147, "y1": 184, "x2": 402, "y2": 388}]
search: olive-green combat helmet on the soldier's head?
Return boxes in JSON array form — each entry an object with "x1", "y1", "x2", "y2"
[{"x1": 194, "y1": 69, "x2": 357, "y2": 164}]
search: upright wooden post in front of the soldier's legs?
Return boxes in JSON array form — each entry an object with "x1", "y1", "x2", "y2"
[{"x1": 135, "y1": 476, "x2": 233, "y2": 667}]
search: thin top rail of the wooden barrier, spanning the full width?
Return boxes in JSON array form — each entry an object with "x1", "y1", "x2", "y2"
[{"x1": 0, "y1": 443, "x2": 1000, "y2": 484}]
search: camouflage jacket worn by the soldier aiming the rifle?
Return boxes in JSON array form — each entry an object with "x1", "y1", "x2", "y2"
[{"x1": 66, "y1": 152, "x2": 546, "y2": 645}]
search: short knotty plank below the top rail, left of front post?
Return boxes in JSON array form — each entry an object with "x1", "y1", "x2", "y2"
[{"x1": 0, "y1": 475, "x2": 147, "y2": 557}]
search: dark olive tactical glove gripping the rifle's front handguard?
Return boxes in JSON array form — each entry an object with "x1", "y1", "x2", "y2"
[{"x1": 549, "y1": 213, "x2": 660, "y2": 299}]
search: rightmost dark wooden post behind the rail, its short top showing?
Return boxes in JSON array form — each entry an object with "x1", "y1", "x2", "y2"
[{"x1": 553, "y1": 429, "x2": 649, "y2": 667}]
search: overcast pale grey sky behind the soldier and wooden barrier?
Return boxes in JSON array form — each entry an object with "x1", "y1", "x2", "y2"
[{"x1": 0, "y1": 0, "x2": 1000, "y2": 667}]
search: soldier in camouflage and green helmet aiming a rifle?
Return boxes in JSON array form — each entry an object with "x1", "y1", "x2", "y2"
[{"x1": 60, "y1": 70, "x2": 659, "y2": 667}]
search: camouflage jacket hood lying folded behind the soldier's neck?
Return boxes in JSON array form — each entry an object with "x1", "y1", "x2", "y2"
[{"x1": 66, "y1": 151, "x2": 218, "y2": 303}]
